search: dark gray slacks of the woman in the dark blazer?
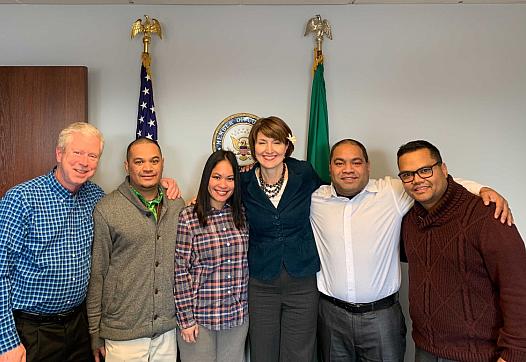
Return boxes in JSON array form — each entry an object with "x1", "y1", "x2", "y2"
[{"x1": 248, "y1": 269, "x2": 319, "y2": 362}]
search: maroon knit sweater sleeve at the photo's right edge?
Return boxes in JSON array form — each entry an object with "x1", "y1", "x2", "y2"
[{"x1": 480, "y1": 216, "x2": 526, "y2": 362}]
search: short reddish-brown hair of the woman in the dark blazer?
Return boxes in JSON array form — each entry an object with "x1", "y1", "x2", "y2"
[{"x1": 248, "y1": 116, "x2": 294, "y2": 159}]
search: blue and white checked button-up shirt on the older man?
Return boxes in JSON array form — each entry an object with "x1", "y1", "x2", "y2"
[{"x1": 0, "y1": 170, "x2": 104, "y2": 354}]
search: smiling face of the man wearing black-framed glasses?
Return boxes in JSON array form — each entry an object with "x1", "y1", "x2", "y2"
[{"x1": 398, "y1": 148, "x2": 447, "y2": 210}]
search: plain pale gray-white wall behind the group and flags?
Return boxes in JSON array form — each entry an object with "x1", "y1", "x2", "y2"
[{"x1": 0, "y1": 5, "x2": 526, "y2": 360}]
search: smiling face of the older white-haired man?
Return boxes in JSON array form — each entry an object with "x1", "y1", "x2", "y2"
[{"x1": 55, "y1": 132, "x2": 102, "y2": 192}]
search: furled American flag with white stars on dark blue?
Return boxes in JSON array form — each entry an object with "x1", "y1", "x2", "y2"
[{"x1": 135, "y1": 64, "x2": 157, "y2": 141}]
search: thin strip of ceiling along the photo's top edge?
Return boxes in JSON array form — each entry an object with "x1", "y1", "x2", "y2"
[{"x1": 4, "y1": 0, "x2": 526, "y2": 5}]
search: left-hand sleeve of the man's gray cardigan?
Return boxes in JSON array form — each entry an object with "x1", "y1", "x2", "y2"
[{"x1": 86, "y1": 206, "x2": 113, "y2": 350}]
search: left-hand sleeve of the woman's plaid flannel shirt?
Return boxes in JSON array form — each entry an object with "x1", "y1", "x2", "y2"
[{"x1": 174, "y1": 209, "x2": 196, "y2": 329}]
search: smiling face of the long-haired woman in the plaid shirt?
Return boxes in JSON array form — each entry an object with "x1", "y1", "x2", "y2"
[{"x1": 208, "y1": 160, "x2": 235, "y2": 210}]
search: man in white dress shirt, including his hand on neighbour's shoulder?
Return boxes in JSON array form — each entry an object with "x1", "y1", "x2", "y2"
[{"x1": 311, "y1": 139, "x2": 507, "y2": 362}]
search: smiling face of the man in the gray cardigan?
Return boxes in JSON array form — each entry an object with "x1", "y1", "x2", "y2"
[{"x1": 124, "y1": 143, "x2": 163, "y2": 199}]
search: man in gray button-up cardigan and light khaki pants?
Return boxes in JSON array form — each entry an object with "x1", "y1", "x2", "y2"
[{"x1": 87, "y1": 138, "x2": 184, "y2": 362}]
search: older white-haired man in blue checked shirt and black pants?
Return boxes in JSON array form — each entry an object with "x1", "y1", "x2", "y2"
[{"x1": 0, "y1": 123, "x2": 104, "y2": 361}]
